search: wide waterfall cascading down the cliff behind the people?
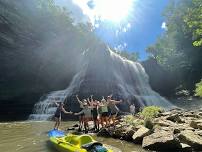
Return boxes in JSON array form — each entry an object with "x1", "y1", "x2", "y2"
[{"x1": 29, "y1": 45, "x2": 171, "y2": 120}]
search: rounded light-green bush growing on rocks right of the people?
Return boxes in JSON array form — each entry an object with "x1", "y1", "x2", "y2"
[{"x1": 140, "y1": 106, "x2": 162, "y2": 120}]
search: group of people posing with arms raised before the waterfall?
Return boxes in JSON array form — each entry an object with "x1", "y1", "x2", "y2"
[{"x1": 54, "y1": 95, "x2": 122, "y2": 132}]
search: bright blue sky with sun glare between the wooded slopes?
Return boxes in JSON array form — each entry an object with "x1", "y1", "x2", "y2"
[{"x1": 55, "y1": 0, "x2": 169, "y2": 60}]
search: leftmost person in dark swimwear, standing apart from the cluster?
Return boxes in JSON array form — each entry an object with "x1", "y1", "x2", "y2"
[{"x1": 54, "y1": 102, "x2": 72, "y2": 130}]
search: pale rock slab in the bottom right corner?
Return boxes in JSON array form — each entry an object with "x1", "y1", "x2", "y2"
[{"x1": 178, "y1": 130, "x2": 202, "y2": 150}]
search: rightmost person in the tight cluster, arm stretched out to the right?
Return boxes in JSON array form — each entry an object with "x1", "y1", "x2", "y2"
[{"x1": 107, "y1": 95, "x2": 122, "y2": 127}]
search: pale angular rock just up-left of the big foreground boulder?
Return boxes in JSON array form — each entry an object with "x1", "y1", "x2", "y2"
[{"x1": 132, "y1": 126, "x2": 150, "y2": 143}]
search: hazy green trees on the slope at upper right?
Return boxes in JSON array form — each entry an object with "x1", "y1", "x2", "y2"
[{"x1": 147, "y1": 0, "x2": 202, "y2": 91}]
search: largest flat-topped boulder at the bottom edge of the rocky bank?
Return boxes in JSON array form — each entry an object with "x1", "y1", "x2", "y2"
[{"x1": 142, "y1": 130, "x2": 181, "y2": 150}]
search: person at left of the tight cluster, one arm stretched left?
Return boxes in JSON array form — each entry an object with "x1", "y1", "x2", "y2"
[{"x1": 74, "y1": 102, "x2": 91, "y2": 133}]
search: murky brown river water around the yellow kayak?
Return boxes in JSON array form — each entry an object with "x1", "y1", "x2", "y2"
[{"x1": 0, "y1": 121, "x2": 146, "y2": 152}]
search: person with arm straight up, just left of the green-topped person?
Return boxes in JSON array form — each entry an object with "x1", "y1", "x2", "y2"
[{"x1": 89, "y1": 95, "x2": 99, "y2": 130}]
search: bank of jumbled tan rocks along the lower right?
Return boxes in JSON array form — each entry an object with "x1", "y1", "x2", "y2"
[{"x1": 97, "y1": 108, "x2": 202, "y2": 151}]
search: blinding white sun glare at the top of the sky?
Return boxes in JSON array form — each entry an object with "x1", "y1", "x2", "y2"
[{"x1": 74, "y1": 0, "x2": 134, "y2": 22}]
